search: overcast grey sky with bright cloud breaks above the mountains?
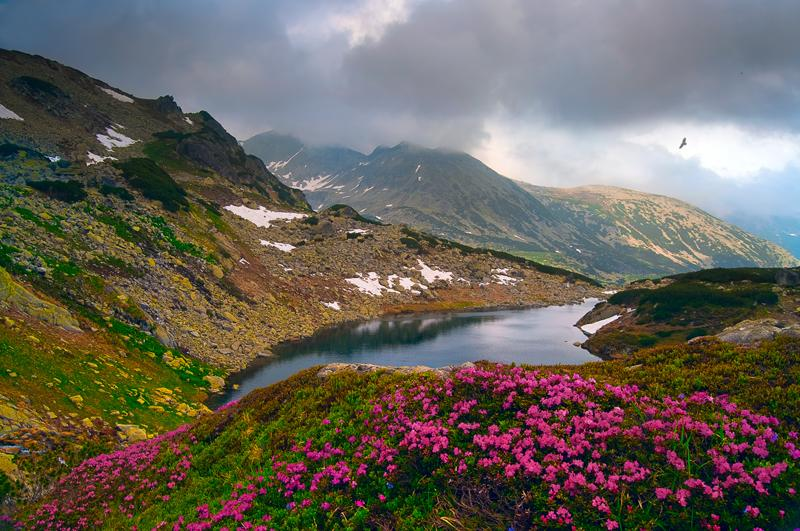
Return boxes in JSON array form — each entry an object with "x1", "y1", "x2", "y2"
[{"x1": 0, "y1": 0, "x2": 800, "y2": 217}]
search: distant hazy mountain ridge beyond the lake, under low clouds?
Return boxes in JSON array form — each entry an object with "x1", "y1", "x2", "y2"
[{"x1": 243, "y1": 132, "x2": 795, "y2": 279}]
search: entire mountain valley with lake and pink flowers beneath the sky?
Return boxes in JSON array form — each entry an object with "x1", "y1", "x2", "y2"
[{"x1": 0, "y1": 50, "x2": 800, "y2": 531}]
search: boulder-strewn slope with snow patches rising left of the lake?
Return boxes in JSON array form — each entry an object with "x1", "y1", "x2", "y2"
[{"x1": 0, "y1": 47, "x2": 597, "y2": 495}]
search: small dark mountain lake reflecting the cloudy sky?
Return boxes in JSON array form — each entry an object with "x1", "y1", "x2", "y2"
[{"x1": 208, "y1": 299, "x2": 599, "y2": 407}]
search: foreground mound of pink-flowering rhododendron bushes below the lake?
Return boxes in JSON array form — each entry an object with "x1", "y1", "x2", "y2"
[{"x1": 23, "y1": 365, "x2": 800, "y2": 530}]
